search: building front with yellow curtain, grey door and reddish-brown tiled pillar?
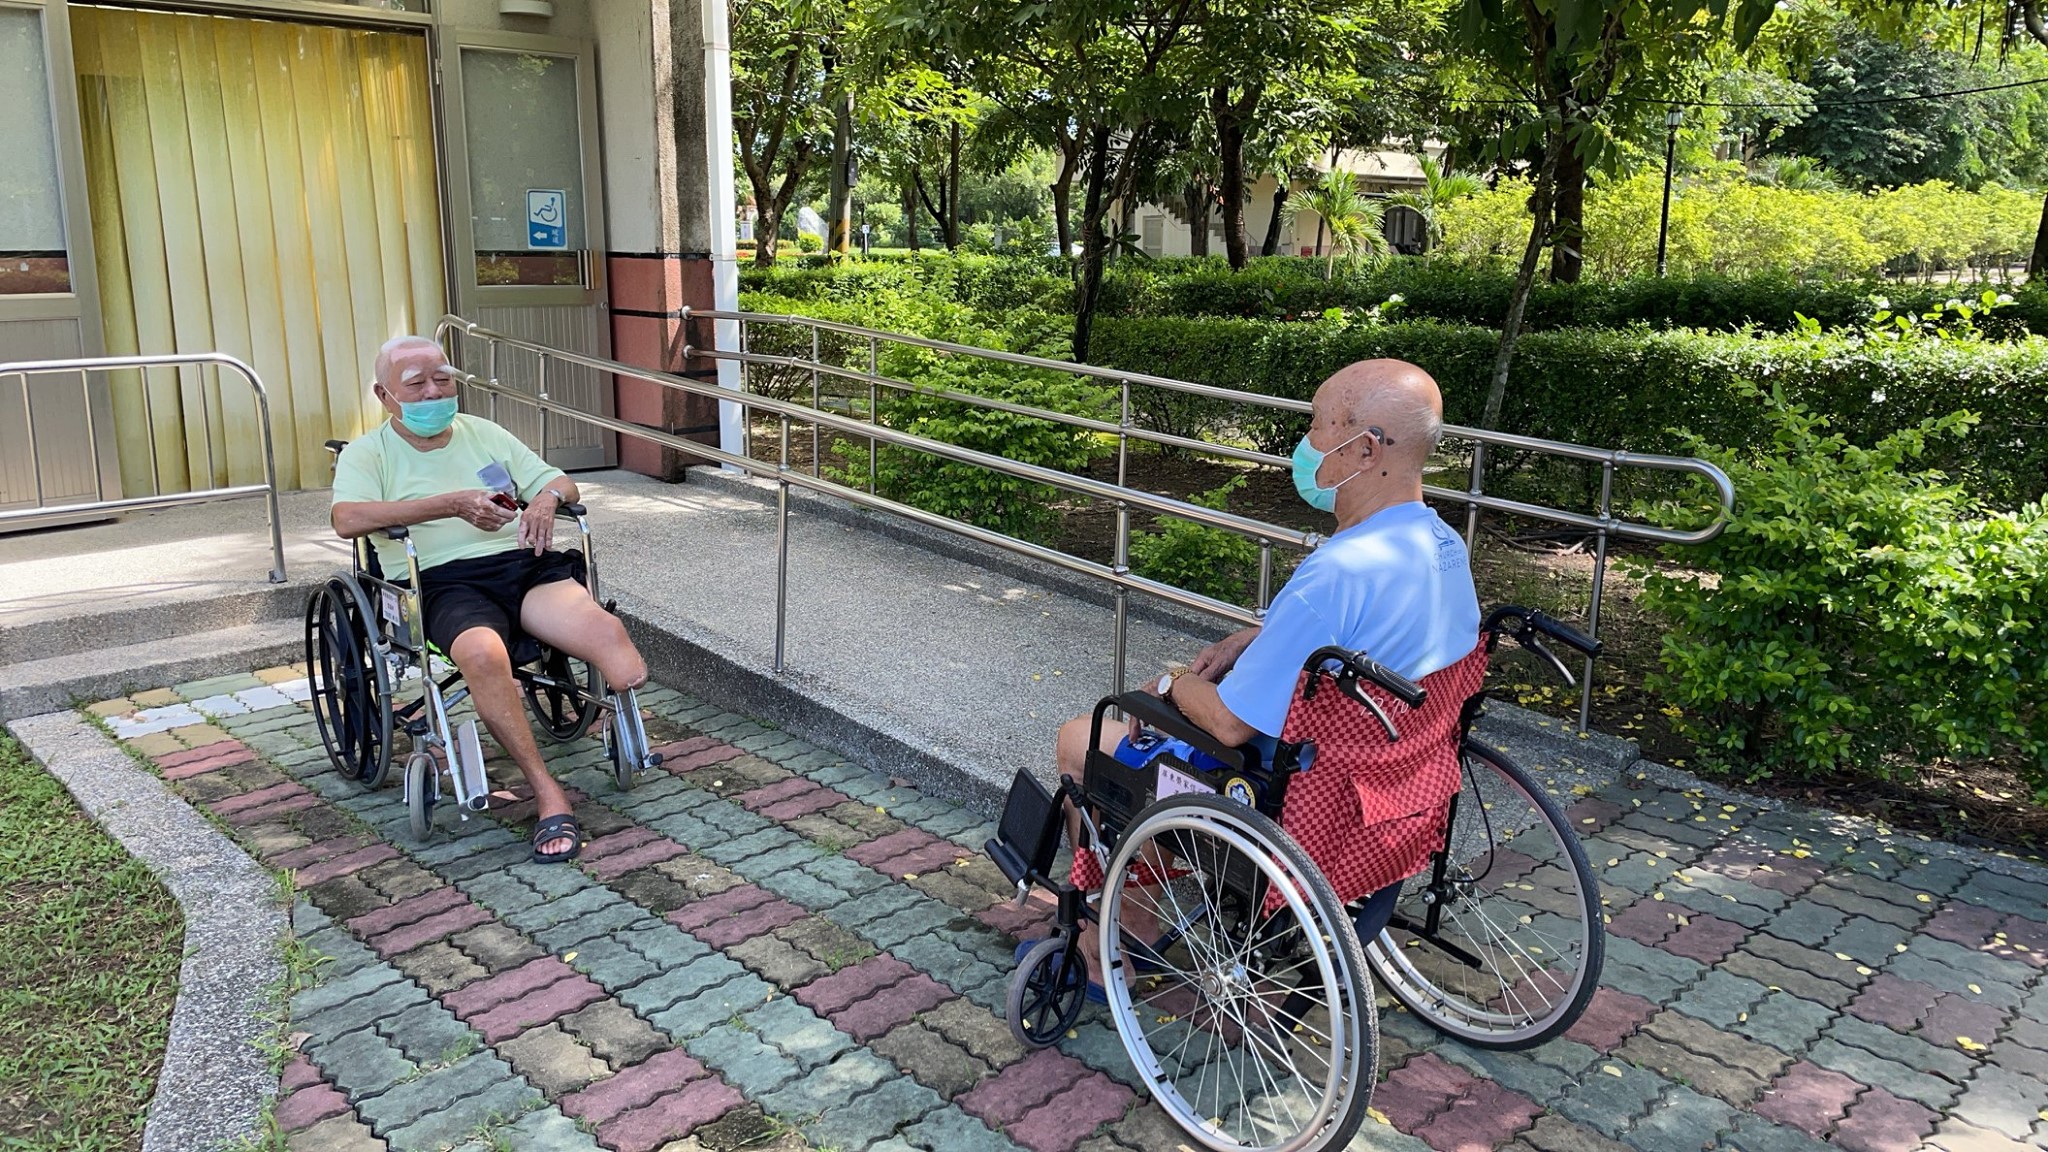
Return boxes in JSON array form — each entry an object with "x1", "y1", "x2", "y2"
[{"x1": 0, "y1": 0, "x2": 737, "y2": 520}]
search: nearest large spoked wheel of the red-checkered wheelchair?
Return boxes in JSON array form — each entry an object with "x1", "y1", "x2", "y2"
[{"x1": 1102, "y1": 795, "x2": 1378, "y2": 1152}]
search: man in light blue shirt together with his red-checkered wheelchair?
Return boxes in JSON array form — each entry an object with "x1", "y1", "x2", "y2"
[{"x1": 989, "y1": 361, "x2": 1602, "y2": 1152}]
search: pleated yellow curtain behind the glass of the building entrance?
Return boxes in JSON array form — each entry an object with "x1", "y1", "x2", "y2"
[{"x1": 70, "y1": 4, "x2": 444, "y2": 496}]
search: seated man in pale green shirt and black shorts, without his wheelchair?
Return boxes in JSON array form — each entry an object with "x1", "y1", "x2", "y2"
[{"x1": 332, "y1": 336, "x2": 647, "y2": 861}]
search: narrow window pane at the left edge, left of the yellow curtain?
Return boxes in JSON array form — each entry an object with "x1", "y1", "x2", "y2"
[{"x1": 0, "y1": 6, "x2": 72, "y2": 295}]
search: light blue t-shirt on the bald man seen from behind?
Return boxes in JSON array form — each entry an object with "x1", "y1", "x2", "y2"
[{"x1": 1219, "y1": 500, "x2": 1479, "y2": 736}]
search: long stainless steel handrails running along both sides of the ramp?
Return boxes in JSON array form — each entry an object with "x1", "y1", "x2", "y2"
[{"x1": 436, "y1": 310, "x2": 1735, "y2": 730}]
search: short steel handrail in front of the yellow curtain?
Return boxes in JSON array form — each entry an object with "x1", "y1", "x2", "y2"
[{"x1": 0, "y1": 353, "x2": 285, "y2": 584}]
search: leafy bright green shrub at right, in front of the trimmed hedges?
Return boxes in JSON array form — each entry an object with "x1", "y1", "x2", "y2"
[{"x1": 1642, "y1": 387, "x2": 2048, "y2": 799}]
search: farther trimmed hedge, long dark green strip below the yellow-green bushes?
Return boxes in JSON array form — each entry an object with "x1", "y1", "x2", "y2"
[{"x1": 741, "y1": 254, "x2": 2048, "y2": 336}]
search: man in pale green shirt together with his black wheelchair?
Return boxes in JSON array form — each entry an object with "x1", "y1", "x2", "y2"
[{"x1": 307, "y1": 336, "x2": 659, "y2": 861}]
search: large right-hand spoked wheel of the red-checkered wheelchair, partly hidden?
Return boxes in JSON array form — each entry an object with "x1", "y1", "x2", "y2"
[{"x1": 1368, "y1": 742, "x2": 1606, "y2": 1050}]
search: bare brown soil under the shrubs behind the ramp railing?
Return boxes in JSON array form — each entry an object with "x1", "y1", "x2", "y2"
[{"x1": 754, "y1": 420, "x2": 2048, "y2": 855}]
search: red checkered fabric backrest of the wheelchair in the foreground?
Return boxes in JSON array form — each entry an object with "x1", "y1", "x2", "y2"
[{"x1": 1268, "y1": 644, "x2": 1487, "y2": 904}]
